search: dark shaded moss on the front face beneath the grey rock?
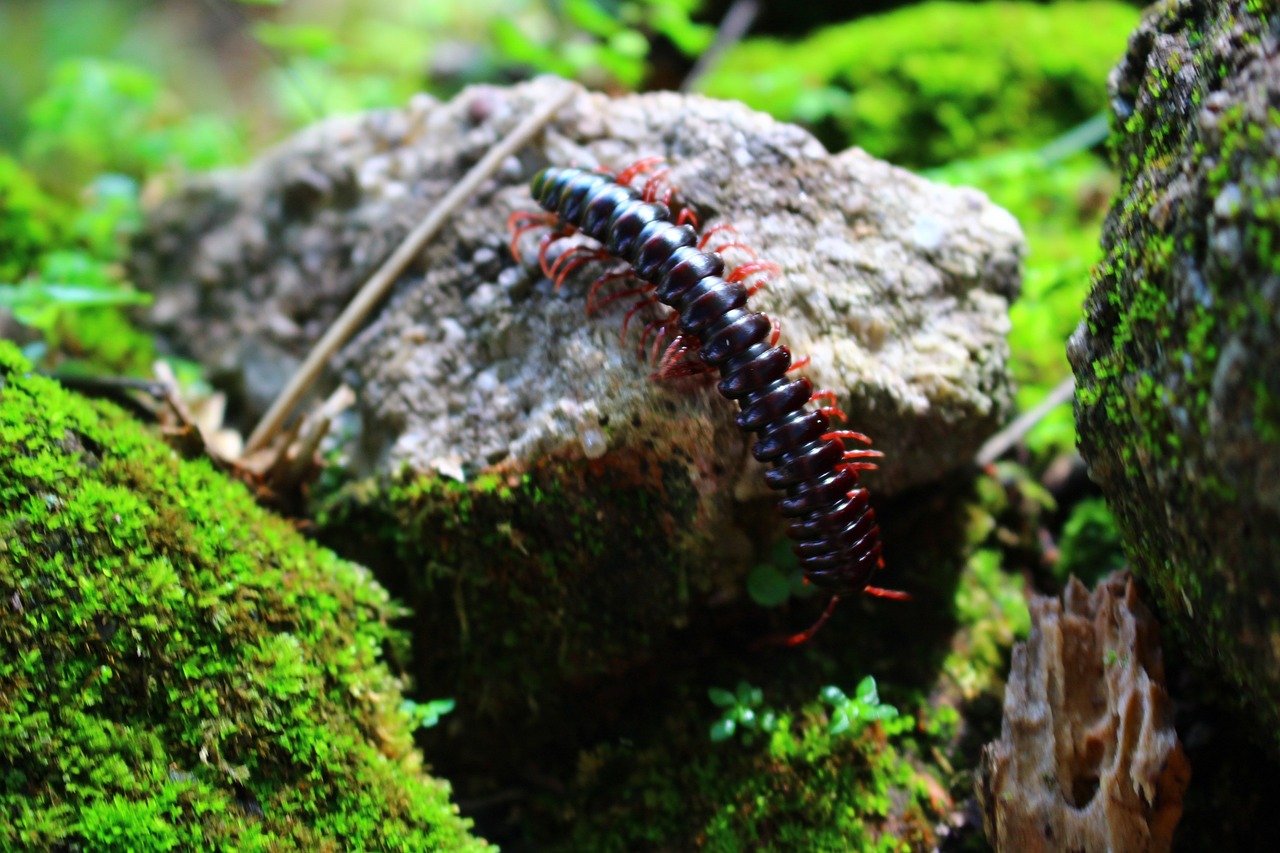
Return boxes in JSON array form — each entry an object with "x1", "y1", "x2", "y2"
[{"x1": 317, "y1": 438, "x2": 739, "y2": 727}]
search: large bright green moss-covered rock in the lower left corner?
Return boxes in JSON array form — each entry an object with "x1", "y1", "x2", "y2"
[{"x1": 0, "y1": 342, "x2": 486, "y2": 850}]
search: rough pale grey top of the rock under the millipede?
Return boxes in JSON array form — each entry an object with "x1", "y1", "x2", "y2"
[{"x1": 136, "y1": 79, "x2": 1021, "y2": 493}]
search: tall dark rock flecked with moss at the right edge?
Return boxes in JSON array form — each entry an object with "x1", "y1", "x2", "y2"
[{"x1": 1070, "y1": 0, "x2": 1280, "y2": 745}]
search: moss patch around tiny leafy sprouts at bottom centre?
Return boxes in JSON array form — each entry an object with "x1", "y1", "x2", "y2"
[{"x1": 539, "y1": 686, "x2": 947, "y2": 853}]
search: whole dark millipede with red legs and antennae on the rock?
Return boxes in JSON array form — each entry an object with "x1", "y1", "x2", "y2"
[{"x1": 508, "y1": 158, "x2": 906, "y2": 646}]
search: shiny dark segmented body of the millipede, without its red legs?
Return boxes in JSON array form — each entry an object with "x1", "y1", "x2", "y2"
[{"x1": 532, "y1": 168, "x2": 881, "y2": 596}]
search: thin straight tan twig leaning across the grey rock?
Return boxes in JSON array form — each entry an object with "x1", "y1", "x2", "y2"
[{"x1": 244, "y1": 85, "x2": 577, "y2": 453}]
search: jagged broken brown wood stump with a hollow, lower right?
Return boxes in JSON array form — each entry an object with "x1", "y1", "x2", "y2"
[{"x1": 978, "y1": 573, "x2": 1190, "y2": 853}]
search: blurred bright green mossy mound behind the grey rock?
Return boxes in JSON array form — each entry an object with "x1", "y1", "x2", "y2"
[{"x1": 701, "y1": 3, "x2": 1138, "y2": 167}]
